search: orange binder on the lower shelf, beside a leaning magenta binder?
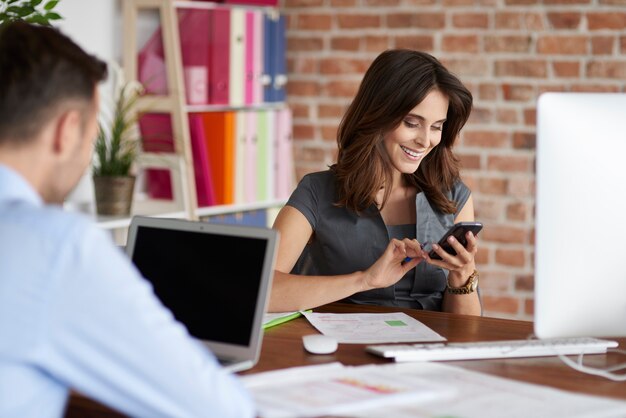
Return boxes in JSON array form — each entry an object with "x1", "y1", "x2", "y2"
[{"x1": 202, "y1": 112, "x2": 235, "y2": 205}]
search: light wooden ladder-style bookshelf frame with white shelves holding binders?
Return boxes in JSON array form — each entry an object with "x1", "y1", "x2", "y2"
[{"x1": 108, "y1": 0, "x2": 288, "y2": 229}]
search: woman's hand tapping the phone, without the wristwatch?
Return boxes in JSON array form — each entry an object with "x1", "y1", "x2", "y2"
[{"x1": 362, "y1": 238, "x2": 426, "y2": 291}]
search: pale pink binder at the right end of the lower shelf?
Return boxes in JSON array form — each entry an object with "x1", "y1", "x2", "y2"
[{"x1": 274, "y1": 109, "x2": 294, "y2": 199}]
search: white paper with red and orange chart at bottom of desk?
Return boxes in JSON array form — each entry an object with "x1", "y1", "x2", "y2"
[{"x1": 242, "y1": 363, "x2": 455, "y2": 418}]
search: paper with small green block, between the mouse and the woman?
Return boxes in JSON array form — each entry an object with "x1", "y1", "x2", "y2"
[{"x1": 303, "y1": 312, "x2": 446, "y2": 344}]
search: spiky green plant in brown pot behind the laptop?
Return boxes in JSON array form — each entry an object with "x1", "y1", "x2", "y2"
[{"x1": 93, "y1": 76, "x2": 142, "y2": 216}]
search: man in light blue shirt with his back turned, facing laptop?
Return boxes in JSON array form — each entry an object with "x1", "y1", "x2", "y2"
[{"x1": 0, "y1": 22, "x2": 254, "y2": 418}]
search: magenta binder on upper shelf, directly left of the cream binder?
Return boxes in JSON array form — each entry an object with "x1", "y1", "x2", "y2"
[{"x1": 209, "y1": 9, "x2": 230, "y2": 105}]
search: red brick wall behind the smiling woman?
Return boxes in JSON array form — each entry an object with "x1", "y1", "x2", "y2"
[{"x1": 282, "y1": 0, "x2": 626, "y2": 319}]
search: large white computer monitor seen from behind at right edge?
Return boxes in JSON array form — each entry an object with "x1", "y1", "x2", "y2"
[{"x1": 534, "y1": 93, "x2": 626, "y2": 338}]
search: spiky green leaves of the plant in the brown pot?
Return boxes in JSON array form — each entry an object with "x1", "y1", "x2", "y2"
[{"x1": 93, "y1": 84, "x2": 142, "y2": 176}]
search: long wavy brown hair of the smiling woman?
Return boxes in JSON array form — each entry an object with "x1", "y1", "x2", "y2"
[{"x1": 331, "y1": 49, "x2": 472, "y2": 213}]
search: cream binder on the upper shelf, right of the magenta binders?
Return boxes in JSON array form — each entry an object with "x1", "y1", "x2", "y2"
[{"x1": 228, "y1": 8, "x2": 247, "y2": 106}]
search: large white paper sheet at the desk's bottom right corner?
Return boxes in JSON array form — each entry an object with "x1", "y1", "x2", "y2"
[{"x1": 350, "y1": 362, "x2": 626, "y2": 418}]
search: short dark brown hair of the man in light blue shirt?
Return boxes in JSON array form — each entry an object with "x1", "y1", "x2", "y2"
[{"x1": 0, "y1": 21, "x2": 107, "y2": 144}]
